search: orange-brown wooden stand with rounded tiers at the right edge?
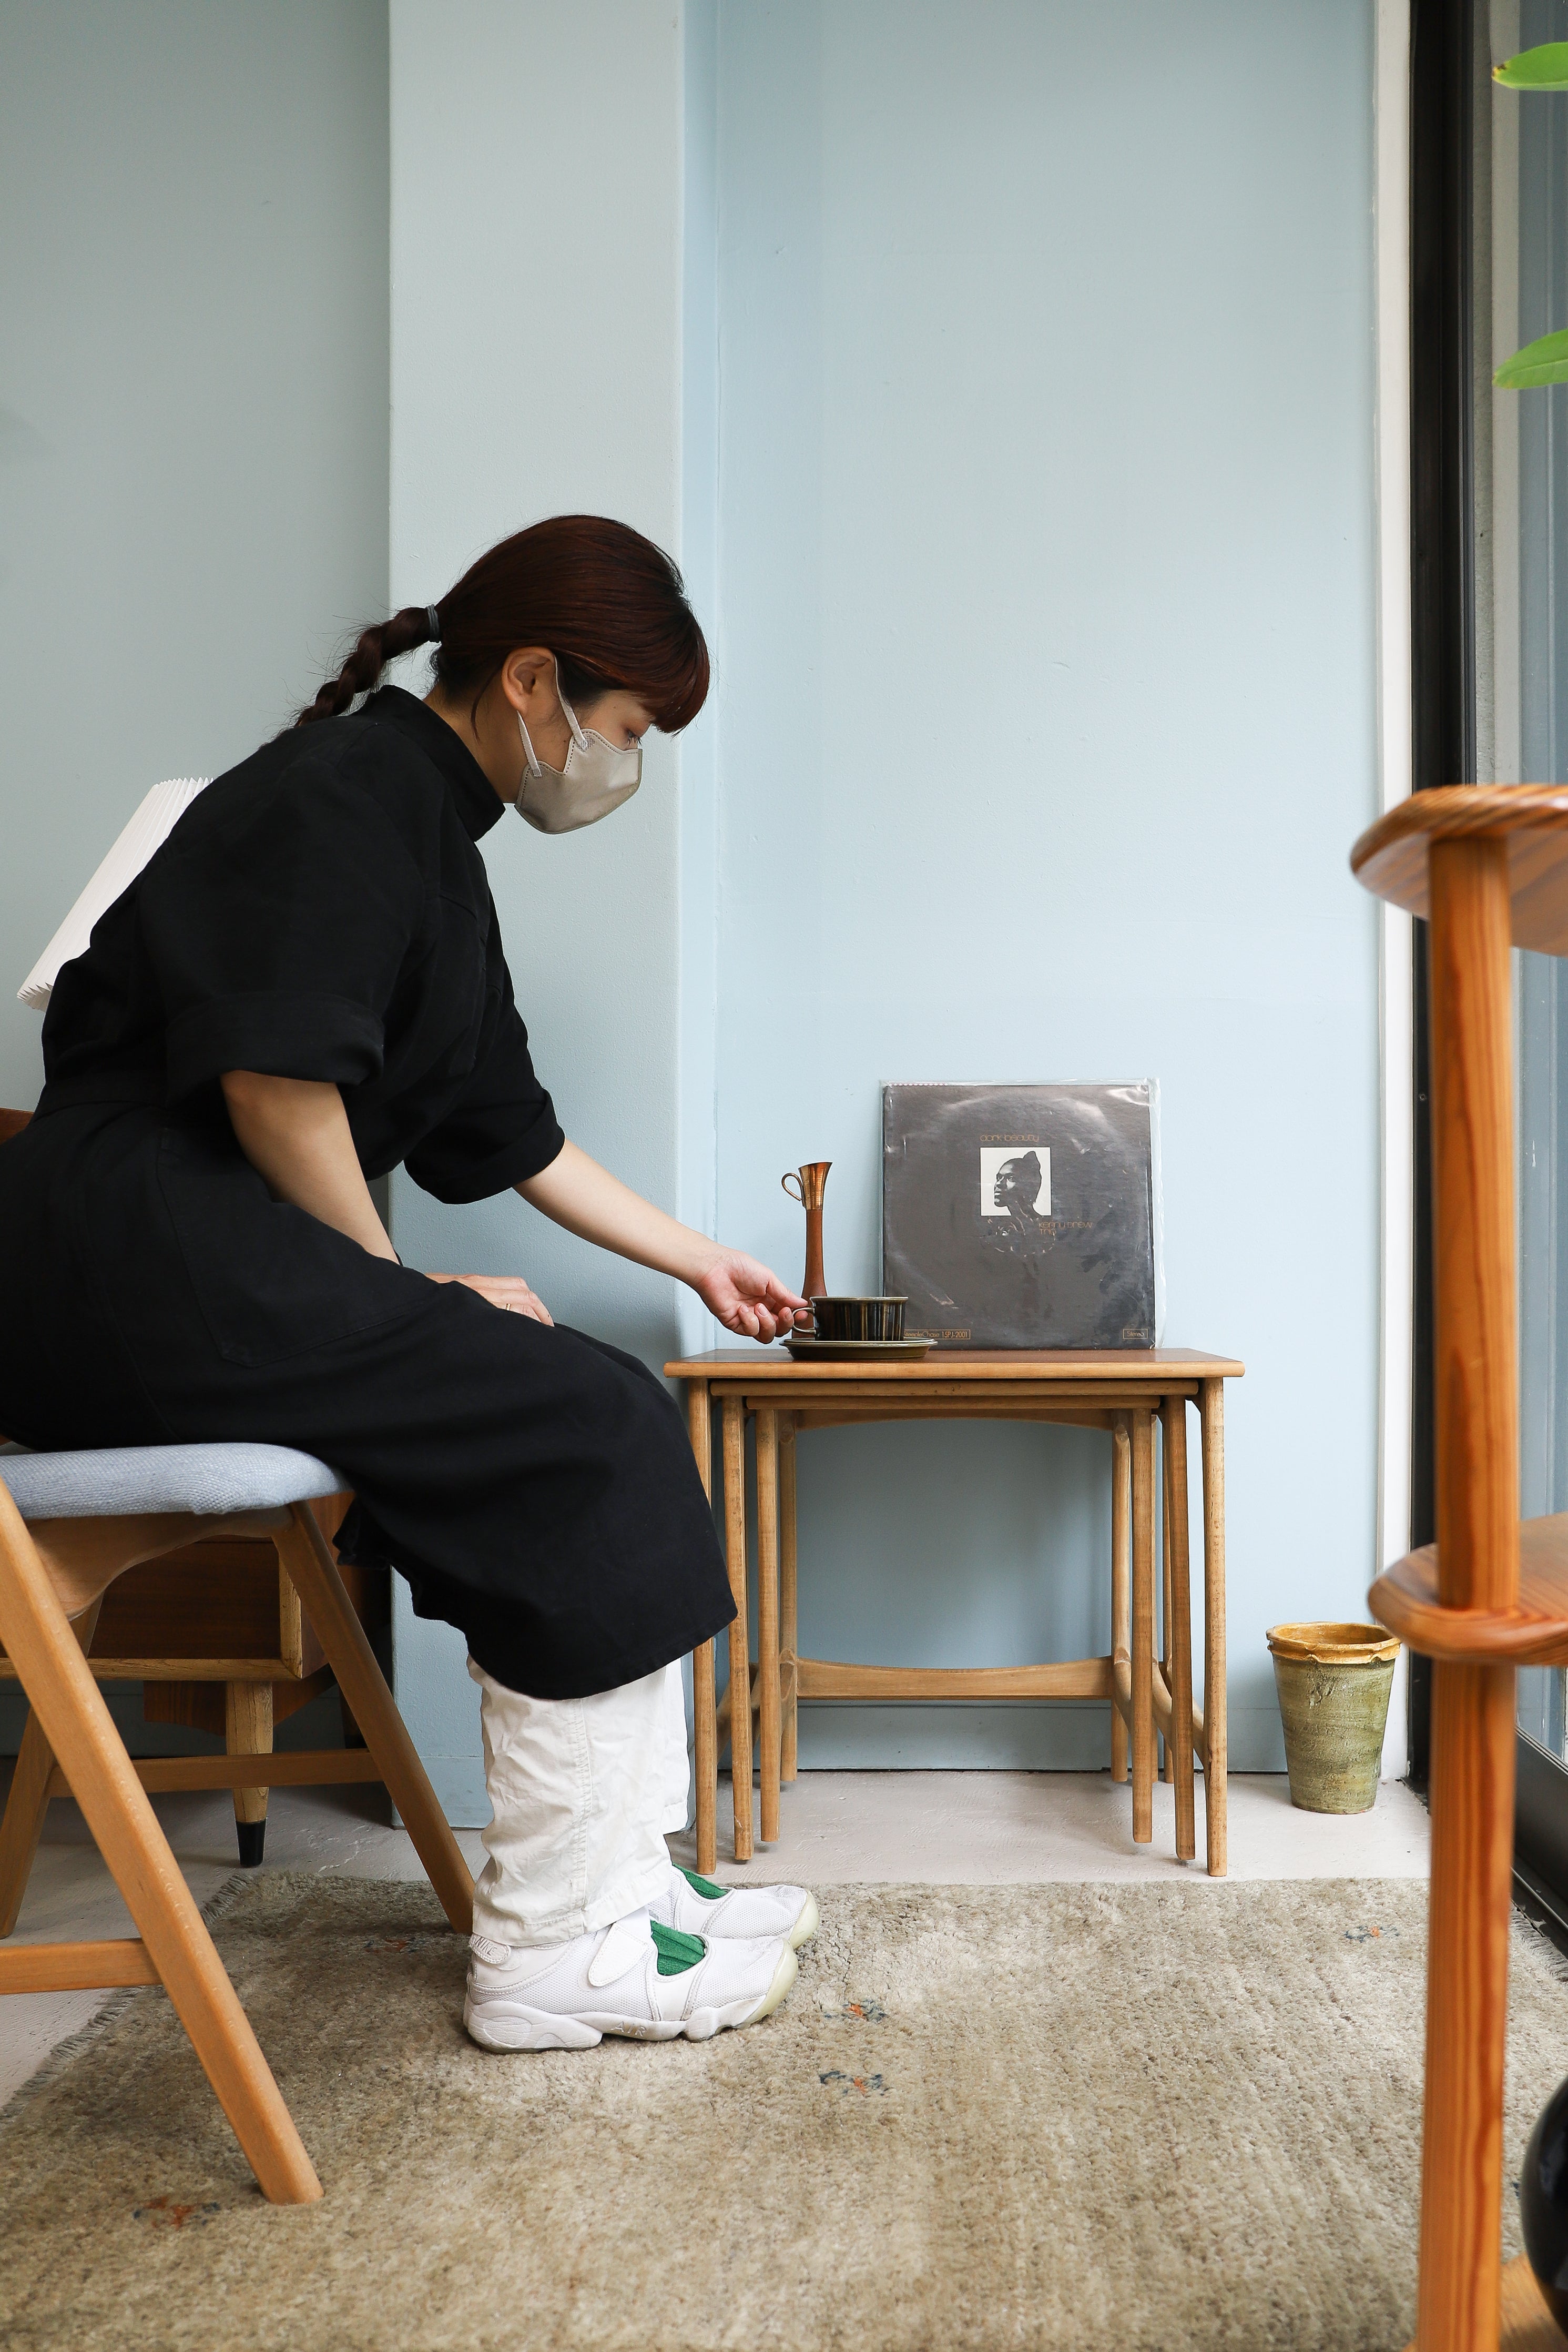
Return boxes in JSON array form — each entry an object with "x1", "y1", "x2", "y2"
[{"x1": 1352, "y1": 783, "x2": 1568, "y2": 2352}]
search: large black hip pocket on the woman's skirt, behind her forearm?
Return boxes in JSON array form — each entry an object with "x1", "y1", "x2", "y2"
[{"x1": 158, "y1": 1127, "x2": 428, "y2": 1364}]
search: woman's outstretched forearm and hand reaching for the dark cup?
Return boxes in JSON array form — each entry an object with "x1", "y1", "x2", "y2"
[{"x1": 517, "y1": 1143, "x2": 811, "y2": 1341}]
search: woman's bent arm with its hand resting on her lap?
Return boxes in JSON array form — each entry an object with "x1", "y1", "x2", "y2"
[{"x1": 221, "y1": 1070, "x2": 550, "y2": 1322}]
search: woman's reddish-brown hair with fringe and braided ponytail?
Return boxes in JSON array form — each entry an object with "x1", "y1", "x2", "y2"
[{"x1": 296, "y1": 515, "x2": 708, "y2": 734}]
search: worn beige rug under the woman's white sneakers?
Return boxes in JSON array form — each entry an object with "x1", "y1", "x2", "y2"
[{"x1": 0, "y1": 1874, "x2": 1568, "y2": 2352}]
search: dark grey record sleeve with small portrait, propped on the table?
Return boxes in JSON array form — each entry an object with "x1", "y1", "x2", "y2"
[{"x1": 882, "y1": 1082, "x2": 1159, "y2": 1347}]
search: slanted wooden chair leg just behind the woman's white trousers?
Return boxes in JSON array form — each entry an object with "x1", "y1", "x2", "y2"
[{"x1": 275, "y1": 1503, "x2": 473, "y2": 1935}]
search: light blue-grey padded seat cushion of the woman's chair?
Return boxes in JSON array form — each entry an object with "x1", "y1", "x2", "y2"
[{"x1": 0, "y1": 1446, "x2": 348, "y2": 1519}]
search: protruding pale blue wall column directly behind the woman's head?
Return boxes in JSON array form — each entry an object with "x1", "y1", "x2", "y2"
[{"x1": 390, "y1": 0, "x2": 691, "y2": 1823}]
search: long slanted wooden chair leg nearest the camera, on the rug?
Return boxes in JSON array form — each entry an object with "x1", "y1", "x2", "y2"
[{"x1": 0, "y1": 1486, "x2": 322, "y2": 2204}]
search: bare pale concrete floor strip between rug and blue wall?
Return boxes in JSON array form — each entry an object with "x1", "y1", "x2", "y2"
[{"x1": 0, "y1": 1764, "x2": 1427, "y2": 2107}]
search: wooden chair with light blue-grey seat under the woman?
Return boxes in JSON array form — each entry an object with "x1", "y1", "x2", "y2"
[{"x1": 0, "y1": 1444, "x2": 473, "y2": 2204}]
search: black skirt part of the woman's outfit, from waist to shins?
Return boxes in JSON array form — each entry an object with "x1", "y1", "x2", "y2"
[{"x1": 0, "y1": 1106, "x2": 734, "y2": 1698}]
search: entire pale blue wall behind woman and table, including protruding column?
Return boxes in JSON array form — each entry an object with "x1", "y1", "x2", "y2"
[{"x1": 0, "y1": 0, "x2": 1378, "y2": 1818}]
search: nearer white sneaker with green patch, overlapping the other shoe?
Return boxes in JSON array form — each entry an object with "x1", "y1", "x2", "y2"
[{"x1": 463, "y1": 1912, "x2": 797, "y2": 2051}]
